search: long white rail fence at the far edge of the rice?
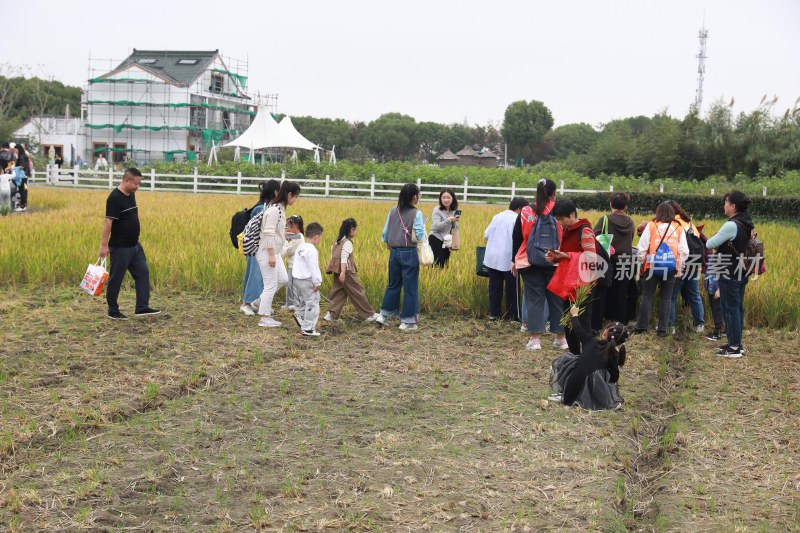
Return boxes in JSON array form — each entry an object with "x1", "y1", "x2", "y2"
[{"x1": 31, "y1": 166, "x2": 614, "y2": 203}]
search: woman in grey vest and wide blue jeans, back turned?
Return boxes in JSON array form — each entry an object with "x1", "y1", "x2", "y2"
[{"x1": 377, "y1": 183, "x2": 425, "y2": 330}]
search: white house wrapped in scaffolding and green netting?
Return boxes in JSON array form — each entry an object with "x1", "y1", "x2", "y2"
[{"x1": 81, "y1": 49, "x2": 277, "y2": 164}]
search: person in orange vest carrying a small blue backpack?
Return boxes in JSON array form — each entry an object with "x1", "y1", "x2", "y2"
[{"x1": 635, "y1": 201, "x2": 689, "y2": 337}]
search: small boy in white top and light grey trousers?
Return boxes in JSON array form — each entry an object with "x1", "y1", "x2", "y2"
[{"x1": 292, "y1": 222, "x2": 323, "y2": 337}]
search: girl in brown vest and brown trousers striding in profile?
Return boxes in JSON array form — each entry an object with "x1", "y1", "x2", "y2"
[{"x1": 323, "y1": 218, "x2": 381, "y2": 322}]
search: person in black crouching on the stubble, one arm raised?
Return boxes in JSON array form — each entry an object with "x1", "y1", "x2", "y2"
[{"x1": 548, "y1": 305, "x2": 628, "y2": 410}]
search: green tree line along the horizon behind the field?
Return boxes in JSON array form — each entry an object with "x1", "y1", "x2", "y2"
[{"x1": 0, "y1": 64, "x2": 800, "y2": 180}]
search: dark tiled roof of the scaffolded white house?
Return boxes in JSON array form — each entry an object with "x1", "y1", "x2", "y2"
[{"x1": 106, "y1": 48, "x2": 219, "y2": 87}]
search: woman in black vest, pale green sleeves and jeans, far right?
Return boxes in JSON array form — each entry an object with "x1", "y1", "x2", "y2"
[{"x1": 706, "y1": 191, "x2": 754, "y2": 359}]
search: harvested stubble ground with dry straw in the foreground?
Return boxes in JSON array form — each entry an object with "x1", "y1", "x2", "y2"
[{"x1": 0, "y1": 289, "x2": 800, "y2": 531}]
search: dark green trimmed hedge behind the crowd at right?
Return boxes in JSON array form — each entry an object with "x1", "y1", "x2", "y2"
[{"x1": 561, "y1": 193, "x2": 800, "y2": 220}]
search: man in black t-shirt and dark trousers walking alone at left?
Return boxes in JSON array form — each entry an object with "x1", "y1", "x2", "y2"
[{"x1": 100, "y1": 168, "x2": 161, "y2": 320}]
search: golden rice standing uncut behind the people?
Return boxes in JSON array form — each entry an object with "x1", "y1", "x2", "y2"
[{"x1": 0, "y1": 187, "x2": 800, "y2": 329}]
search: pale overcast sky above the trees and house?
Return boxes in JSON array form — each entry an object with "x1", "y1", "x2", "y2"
[{"x1": 6, "y1": 0, "x2": 800, "y2": 126}]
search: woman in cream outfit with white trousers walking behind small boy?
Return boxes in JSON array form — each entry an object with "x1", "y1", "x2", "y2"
[{"x1": 256, "y1": 181, "x2": 300, "y2": 328}]
